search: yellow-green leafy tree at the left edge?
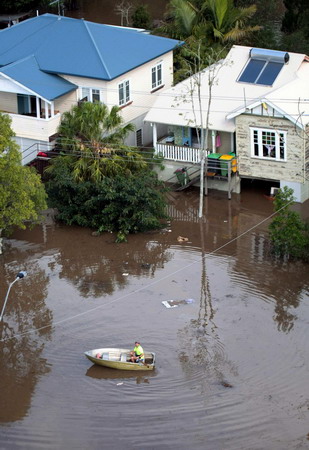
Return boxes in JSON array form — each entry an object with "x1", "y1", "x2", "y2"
[{"x1": 0, "y1": 113, "x2": 46, "y2": 252}]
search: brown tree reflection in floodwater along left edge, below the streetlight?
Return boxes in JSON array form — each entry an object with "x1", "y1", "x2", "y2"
[{"x1": 0, "y1": 255, "x2": 52, "y2": 423}]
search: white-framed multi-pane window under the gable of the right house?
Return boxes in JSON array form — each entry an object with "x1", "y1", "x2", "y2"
[{"x1": 250, "y1": 128, "x2": 286, "y2": 161}]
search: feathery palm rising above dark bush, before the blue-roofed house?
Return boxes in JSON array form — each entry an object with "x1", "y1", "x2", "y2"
[{"x1": 46, "y1": 102, "x2": 147, "y2": 183}]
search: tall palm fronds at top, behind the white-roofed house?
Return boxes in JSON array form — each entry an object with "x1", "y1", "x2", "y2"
[{"x1": 155, "y1": 0, "x2": 261, "y2": 82}]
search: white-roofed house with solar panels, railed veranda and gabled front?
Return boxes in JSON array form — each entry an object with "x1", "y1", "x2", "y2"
[{"x1": 145, "y1": 46, "x2": 309, "y2": 202}]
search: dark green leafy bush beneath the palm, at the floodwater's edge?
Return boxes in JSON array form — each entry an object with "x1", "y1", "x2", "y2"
[{"x1": 47, "y1": 158, "x2": 166, "y2": 242}]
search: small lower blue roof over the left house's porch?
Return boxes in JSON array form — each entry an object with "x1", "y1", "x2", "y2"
[{"x1": 0, "y1": 56, "x2": 77, "y2": 100}]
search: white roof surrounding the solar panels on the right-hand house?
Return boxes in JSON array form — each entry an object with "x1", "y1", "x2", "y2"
[{"x1": 144, "y1": 45, "x2": 309, "y2": 132}]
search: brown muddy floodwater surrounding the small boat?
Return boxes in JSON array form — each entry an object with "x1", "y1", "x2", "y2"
[{"x1": 0, "y1": 187, "x2": 309, "y2": 450}]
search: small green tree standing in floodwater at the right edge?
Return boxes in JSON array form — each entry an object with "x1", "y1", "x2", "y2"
[{"x1": 269, "y1": 186, "x2": 309, "y2": 261}]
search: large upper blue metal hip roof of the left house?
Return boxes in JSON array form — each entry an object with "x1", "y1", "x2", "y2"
[{"x1": 0, "y1": 14, "x2": 182, "y2": 80}]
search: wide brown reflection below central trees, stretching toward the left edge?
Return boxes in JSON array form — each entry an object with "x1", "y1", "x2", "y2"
[{"x1": 5, "y1": 224, "x2": 172, "y2": 298}]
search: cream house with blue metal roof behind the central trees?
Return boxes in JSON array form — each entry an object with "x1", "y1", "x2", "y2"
[{"x1": 0, "y1": 14, "x2": 182, "y2": 164}]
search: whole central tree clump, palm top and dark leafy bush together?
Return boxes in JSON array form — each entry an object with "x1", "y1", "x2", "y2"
[{"x1": 46, "y1": 103, "x2": 166, "y2": 241}]
